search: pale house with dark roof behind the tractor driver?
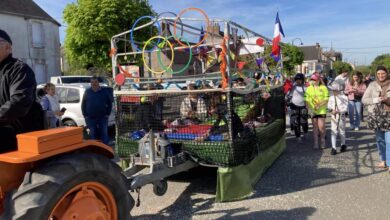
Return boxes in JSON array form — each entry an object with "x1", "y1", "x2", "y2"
[{"x1": 0, "y1": 0, "x2": 61, "y2": 83}]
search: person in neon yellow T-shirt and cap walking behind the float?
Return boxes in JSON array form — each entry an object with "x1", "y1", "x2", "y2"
[{"x1": 305, "y1": 72, "x2": 329, "y2": 149}]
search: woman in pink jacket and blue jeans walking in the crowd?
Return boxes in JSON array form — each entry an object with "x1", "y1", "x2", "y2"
[{"x1": 345, "y1": 71, "x2": 367, "y2": 131}]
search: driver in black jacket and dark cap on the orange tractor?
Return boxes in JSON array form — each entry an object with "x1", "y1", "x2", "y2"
[{"x1": 0, "y1": 29, "x2": 44, "y2": 152}]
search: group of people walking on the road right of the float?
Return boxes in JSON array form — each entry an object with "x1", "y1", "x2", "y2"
[{"x1": 284, "y1": 66, "x2": 390, "y2": 172}]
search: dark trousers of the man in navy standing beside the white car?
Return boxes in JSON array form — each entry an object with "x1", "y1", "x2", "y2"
[{"x1": 85, "y1": 117, "x2": 109, "y2": 144}]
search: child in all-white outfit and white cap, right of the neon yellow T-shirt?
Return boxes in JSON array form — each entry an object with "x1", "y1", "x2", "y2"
[{"x1": 328, "y1": 80, "x2": 348, "y2": 155}]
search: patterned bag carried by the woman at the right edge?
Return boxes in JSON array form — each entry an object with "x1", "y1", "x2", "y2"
[{"x1": 367, "y1": 103, "x2": 390, "y2": 131}]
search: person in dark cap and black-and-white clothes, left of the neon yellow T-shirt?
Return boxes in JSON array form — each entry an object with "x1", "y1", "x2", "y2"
[{"x1": 287, "y1": 73, "x2": 309, "y2": 143}]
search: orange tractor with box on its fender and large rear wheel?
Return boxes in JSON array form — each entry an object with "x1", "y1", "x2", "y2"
[{"x1": 0, "y1": 127, "x2": 134, "y2": 220}]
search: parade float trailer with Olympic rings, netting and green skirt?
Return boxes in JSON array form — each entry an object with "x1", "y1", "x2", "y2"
[{"x1": 111, "y1": 8, "x2": 285, "y2": 202}]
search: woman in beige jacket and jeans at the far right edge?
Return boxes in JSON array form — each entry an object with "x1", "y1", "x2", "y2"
[{"x1": 362, "y1": 66, "x2": 390, "y2": 172}]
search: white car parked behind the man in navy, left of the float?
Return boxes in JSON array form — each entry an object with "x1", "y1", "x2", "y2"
[{"x1": 38, "y1": 84, "x2": 115, "y2": 127}]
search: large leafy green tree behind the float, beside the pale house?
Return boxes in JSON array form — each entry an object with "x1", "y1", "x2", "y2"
[{"x1": 64, "y1": 0, "x2": 155, "y2": 71}]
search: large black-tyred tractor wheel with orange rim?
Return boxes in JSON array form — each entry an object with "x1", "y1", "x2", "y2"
[{"x1": 7, "y1": 153, "x2": 134, "y2": 220}]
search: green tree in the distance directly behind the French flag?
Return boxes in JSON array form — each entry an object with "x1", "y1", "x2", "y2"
[{"x1": 264, "y1": 43, "x2": 304, "y2": 75}]
